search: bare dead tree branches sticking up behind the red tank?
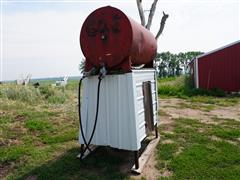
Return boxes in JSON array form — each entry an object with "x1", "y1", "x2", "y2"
[{"x1": 136, "y1": 0, "x2": 169, "y2": 40}]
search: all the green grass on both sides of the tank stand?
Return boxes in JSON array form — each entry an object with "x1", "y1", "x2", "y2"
[{"x1": 0, "y1": 78, "x2": 240, "y2": 179}]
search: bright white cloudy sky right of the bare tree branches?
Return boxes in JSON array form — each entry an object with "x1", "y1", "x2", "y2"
[{"x1": 153, "y1": 2, "x2": 240, "y2": 52}]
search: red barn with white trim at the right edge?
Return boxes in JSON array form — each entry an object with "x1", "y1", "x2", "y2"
[{"x1": 189, "y1": 40, "x2": 240, "y2": 92}]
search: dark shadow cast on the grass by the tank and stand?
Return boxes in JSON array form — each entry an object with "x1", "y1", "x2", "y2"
[{"x1": 18, "y1": 147, "x2": 134, "y2": 180}]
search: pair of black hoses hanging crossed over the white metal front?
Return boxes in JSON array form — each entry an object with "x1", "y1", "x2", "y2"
[{"x1": 78, "y1": 75, "x2": 102, "y2": 159}]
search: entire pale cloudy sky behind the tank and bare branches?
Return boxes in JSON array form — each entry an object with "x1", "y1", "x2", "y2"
[{"x1": 0, "y1": 0, "x2": 240, "y2": 81}]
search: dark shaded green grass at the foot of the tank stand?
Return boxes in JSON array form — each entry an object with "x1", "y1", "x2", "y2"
[{"x1": 12, "y1": 148, "x2": 126, "y2": 180}]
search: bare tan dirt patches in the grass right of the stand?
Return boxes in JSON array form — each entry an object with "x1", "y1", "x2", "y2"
[{"x1": 133, "y1": 98, "x2": 240, "y2": 180}]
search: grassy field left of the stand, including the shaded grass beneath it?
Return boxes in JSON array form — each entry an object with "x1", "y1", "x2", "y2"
[{"x1": 0, "y1": 81, "x2": 132, "y2": 179}]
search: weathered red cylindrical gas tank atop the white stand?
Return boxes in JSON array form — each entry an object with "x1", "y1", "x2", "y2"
[{"x1": 80, "y1": 6, "x2": 157, "y2": 72}]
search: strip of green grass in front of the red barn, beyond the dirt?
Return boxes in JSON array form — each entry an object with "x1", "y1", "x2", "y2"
[{"x1": 158, "y1": 76, "x2": 240, "y2": 109}]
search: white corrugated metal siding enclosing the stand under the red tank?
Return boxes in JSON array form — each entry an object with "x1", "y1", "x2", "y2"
[{"x1": 79, "y1": 70, "x2": 157, "y2": 150}]
